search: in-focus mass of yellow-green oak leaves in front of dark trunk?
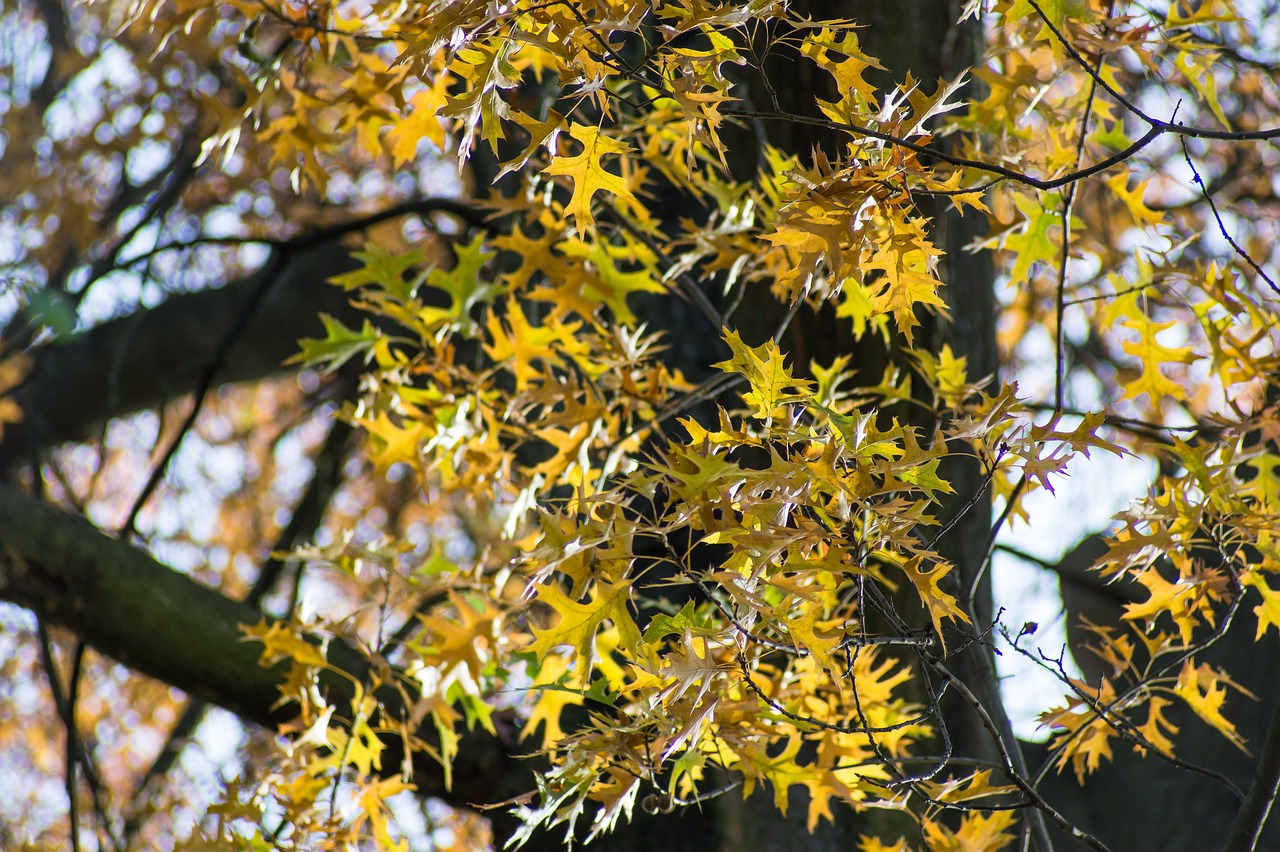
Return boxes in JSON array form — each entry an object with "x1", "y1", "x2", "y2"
[{"x1": 0, "y1": 0, "x2": 1280, "y2": 849}]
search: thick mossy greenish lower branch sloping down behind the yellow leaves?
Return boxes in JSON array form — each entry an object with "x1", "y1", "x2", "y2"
[{"x1": 0, "y1": 486, "x2": 532, "y2": 807}]
